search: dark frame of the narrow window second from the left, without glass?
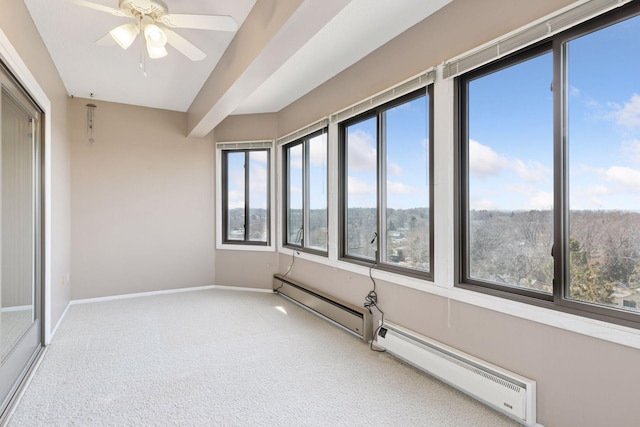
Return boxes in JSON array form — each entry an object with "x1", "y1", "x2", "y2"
[{"x1": 282, "y1": 127, "x2": 329, "y2": 257}]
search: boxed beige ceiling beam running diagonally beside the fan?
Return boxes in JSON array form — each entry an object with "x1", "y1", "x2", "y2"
[{"x1": 187, "y1": 0, "x2": 349, "y2": 138}]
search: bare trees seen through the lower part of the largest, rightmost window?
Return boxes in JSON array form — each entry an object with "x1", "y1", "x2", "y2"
[{"x1": 469, "y1": 210, "x2": 640, "y2": 304}]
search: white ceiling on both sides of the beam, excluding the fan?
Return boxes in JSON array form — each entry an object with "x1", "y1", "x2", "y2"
[{"x1": 24, "y1": 0, "x2": 452, "y2": 118}]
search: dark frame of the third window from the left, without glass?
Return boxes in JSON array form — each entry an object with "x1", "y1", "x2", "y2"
[{"x1": 338, "y1": 84, "x2": 435, "y2": 281}]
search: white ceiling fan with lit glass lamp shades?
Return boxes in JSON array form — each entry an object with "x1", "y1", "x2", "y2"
[{"x1": 66, "y1": 0, "x2": 238, "y2": 61}]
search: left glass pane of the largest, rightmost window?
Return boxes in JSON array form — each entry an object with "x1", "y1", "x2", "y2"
[{"x1": 463, "y1": 46, "x2": 553, "y2": 295}]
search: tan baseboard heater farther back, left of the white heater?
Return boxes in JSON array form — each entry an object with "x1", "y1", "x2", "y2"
[{"x1": 273, "y1": 274, "x2": 373, "y2": 342}]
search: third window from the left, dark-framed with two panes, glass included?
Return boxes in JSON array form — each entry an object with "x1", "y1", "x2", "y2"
[{"x1": 340, "y1": 86, "x2": 433, "y2": 278}]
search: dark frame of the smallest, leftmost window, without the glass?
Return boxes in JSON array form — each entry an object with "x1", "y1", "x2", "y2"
[{"x1": 221, "y1": 148, "x2": 271, "y2": 247}]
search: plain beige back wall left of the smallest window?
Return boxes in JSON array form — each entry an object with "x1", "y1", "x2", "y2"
[{"x1": 70, "y1": 98, "x2": 214, "y2": 299}]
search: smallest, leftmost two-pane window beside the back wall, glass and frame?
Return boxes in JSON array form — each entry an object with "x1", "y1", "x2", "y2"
[{"x1": 222, "y1": 149, "x2": 270, "y2": 245}]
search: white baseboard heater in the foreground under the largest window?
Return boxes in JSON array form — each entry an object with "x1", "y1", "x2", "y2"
[{"x1": 376, "y1": 321, "x2": 538, "y2": 426}]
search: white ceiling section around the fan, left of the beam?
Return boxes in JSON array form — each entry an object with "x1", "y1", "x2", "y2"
[{"x1": 25, "y1": 0, "x2": 255, "y2": 111}]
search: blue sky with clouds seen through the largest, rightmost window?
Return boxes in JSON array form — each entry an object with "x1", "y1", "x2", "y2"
[{"x1": 469, "y1": 13, "x2": 640, "y2": 210}]
